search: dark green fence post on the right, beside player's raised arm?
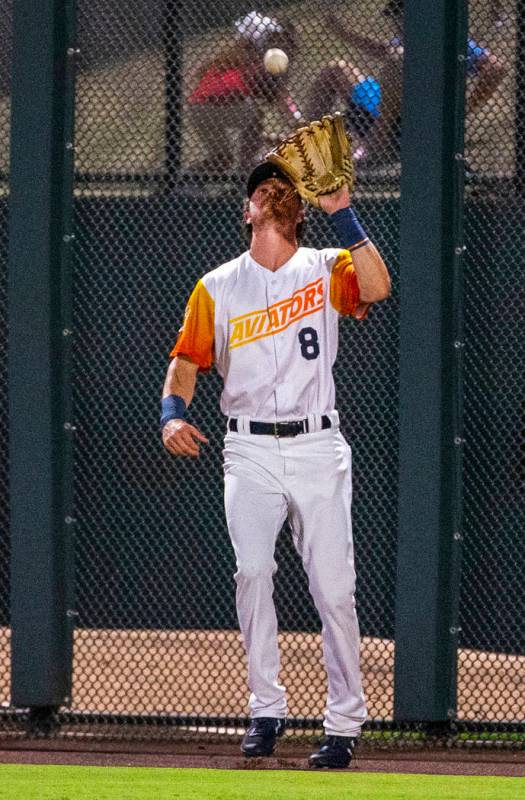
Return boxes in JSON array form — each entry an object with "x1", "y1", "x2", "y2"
[{"x1": 394, "y1": 0, "x2": 467, "y2": 723}]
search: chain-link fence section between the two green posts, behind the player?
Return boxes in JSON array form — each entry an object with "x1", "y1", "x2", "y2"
[{"x1": 66, "y1": 2, "x2": 399, "y2": 740}]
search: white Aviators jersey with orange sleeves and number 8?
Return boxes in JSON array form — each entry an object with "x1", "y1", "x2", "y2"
[{"x1": 171, "y1": 247, "x2": 368, "y2": 422}]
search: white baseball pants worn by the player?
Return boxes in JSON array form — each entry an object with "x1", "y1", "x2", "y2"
[{"x1": 224, "y1": 414, "x2": 366, "y2": 736}]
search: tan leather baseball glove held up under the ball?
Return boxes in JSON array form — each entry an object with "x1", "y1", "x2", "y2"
[{"x1": 266, "y1": 114, "x2": 354, "y2": 208}]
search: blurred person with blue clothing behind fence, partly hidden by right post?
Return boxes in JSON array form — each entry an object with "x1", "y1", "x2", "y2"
[{"x1": 304, "y1": 0, "x2": 506, "y2": 163}]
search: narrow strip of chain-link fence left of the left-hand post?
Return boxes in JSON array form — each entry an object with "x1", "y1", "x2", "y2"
[{"x1": 0, "y1": 0, "x2": 12, "y2": 728}]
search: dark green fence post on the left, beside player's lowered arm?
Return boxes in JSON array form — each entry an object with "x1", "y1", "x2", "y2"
[{"x1": 8, "y1": 0, "x2": 76, "y2": 711}]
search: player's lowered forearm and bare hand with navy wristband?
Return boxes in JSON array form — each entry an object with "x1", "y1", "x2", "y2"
[{"x1": 160, "y1": 356, "x2": 208, "y2": 456}]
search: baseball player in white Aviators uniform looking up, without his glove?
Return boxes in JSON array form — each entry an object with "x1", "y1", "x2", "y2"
[{"x1": 161, "y1": 162, "x2": 390, "y2": 768}]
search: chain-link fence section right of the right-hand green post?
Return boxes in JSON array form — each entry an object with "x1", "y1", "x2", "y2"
[{"x1": 458, "y1": 2, "x2": 525, "y2": 730}]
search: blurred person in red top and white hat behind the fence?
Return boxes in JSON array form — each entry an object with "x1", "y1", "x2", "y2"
[{"x1": 188, "y1": 11, "x2": 300, "y2": 173}]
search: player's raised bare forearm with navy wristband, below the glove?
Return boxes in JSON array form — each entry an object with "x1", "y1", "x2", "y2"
[{"x1": 319, "y1": 186, "x2": 391, "y2": 304}]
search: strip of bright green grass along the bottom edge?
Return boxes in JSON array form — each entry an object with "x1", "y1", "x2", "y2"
[{"x1": 0, "y1": 764, "x2": 525, "y2": 800}]
